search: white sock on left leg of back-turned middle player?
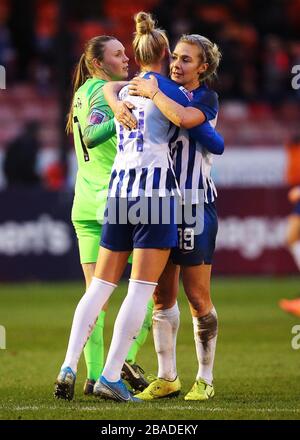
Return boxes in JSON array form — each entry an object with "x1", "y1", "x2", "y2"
[{"x1": 62, "y1": 277, "x2": 117, "y2": 372}]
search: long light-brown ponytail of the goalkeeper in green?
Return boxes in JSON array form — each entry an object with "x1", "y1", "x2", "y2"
[{"x1": 66, "y1": 35, "x2": 116, "y2": 134}]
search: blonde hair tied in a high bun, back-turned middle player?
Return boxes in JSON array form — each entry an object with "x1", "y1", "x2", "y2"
[{"x1": 132, "y1": 12, "x2": 170, "y2": 66}]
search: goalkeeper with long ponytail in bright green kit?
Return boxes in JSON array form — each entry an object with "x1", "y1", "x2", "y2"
[{"x1": 67, "y1": 36, "x2": 153, "y2": 394}]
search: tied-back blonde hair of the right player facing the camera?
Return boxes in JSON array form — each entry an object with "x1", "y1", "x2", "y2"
[{"x1": 178, "y1": 34, "x2": 222, "y2": 81}]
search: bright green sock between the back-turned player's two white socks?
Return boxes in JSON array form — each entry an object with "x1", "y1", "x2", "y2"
[{"x1": 84, "y1": 310, "x2": 106, "y2": 380}]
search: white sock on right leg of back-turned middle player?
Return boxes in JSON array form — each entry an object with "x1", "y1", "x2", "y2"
[{"x1": 102, "y1": 279, "x2": 157, "y2": 382}]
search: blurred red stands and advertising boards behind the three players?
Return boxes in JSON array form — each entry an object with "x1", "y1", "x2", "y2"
[{"x1": 0, "y1": 0, "x2": 300, "y2": 280}]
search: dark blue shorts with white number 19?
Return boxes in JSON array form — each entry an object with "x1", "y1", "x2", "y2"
[{"x1": 171, "y1": 203, "x2": 218, "y2": 266}]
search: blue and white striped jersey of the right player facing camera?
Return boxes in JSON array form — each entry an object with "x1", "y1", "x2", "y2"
[{"x1": 171, "y1": 85, "x2": 218, "y2": 203}]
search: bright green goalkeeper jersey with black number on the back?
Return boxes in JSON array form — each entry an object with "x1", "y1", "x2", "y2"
[{"x1": 72, "y1": 78, "x2": 116, "y2": 221}]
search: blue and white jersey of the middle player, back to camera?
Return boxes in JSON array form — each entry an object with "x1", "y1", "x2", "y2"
[{"x1": 109, "y1": 74, "x2": 195, "y2": 197}]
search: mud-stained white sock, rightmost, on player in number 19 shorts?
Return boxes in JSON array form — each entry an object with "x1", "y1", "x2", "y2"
[{"x1": 193, "y1": 308, "x2": 218, "y2": 385}]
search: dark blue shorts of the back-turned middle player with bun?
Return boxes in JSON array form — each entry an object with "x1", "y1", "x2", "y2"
[{"x1": 100, "y1": 197, "x2": 178, "y2": 251}]
